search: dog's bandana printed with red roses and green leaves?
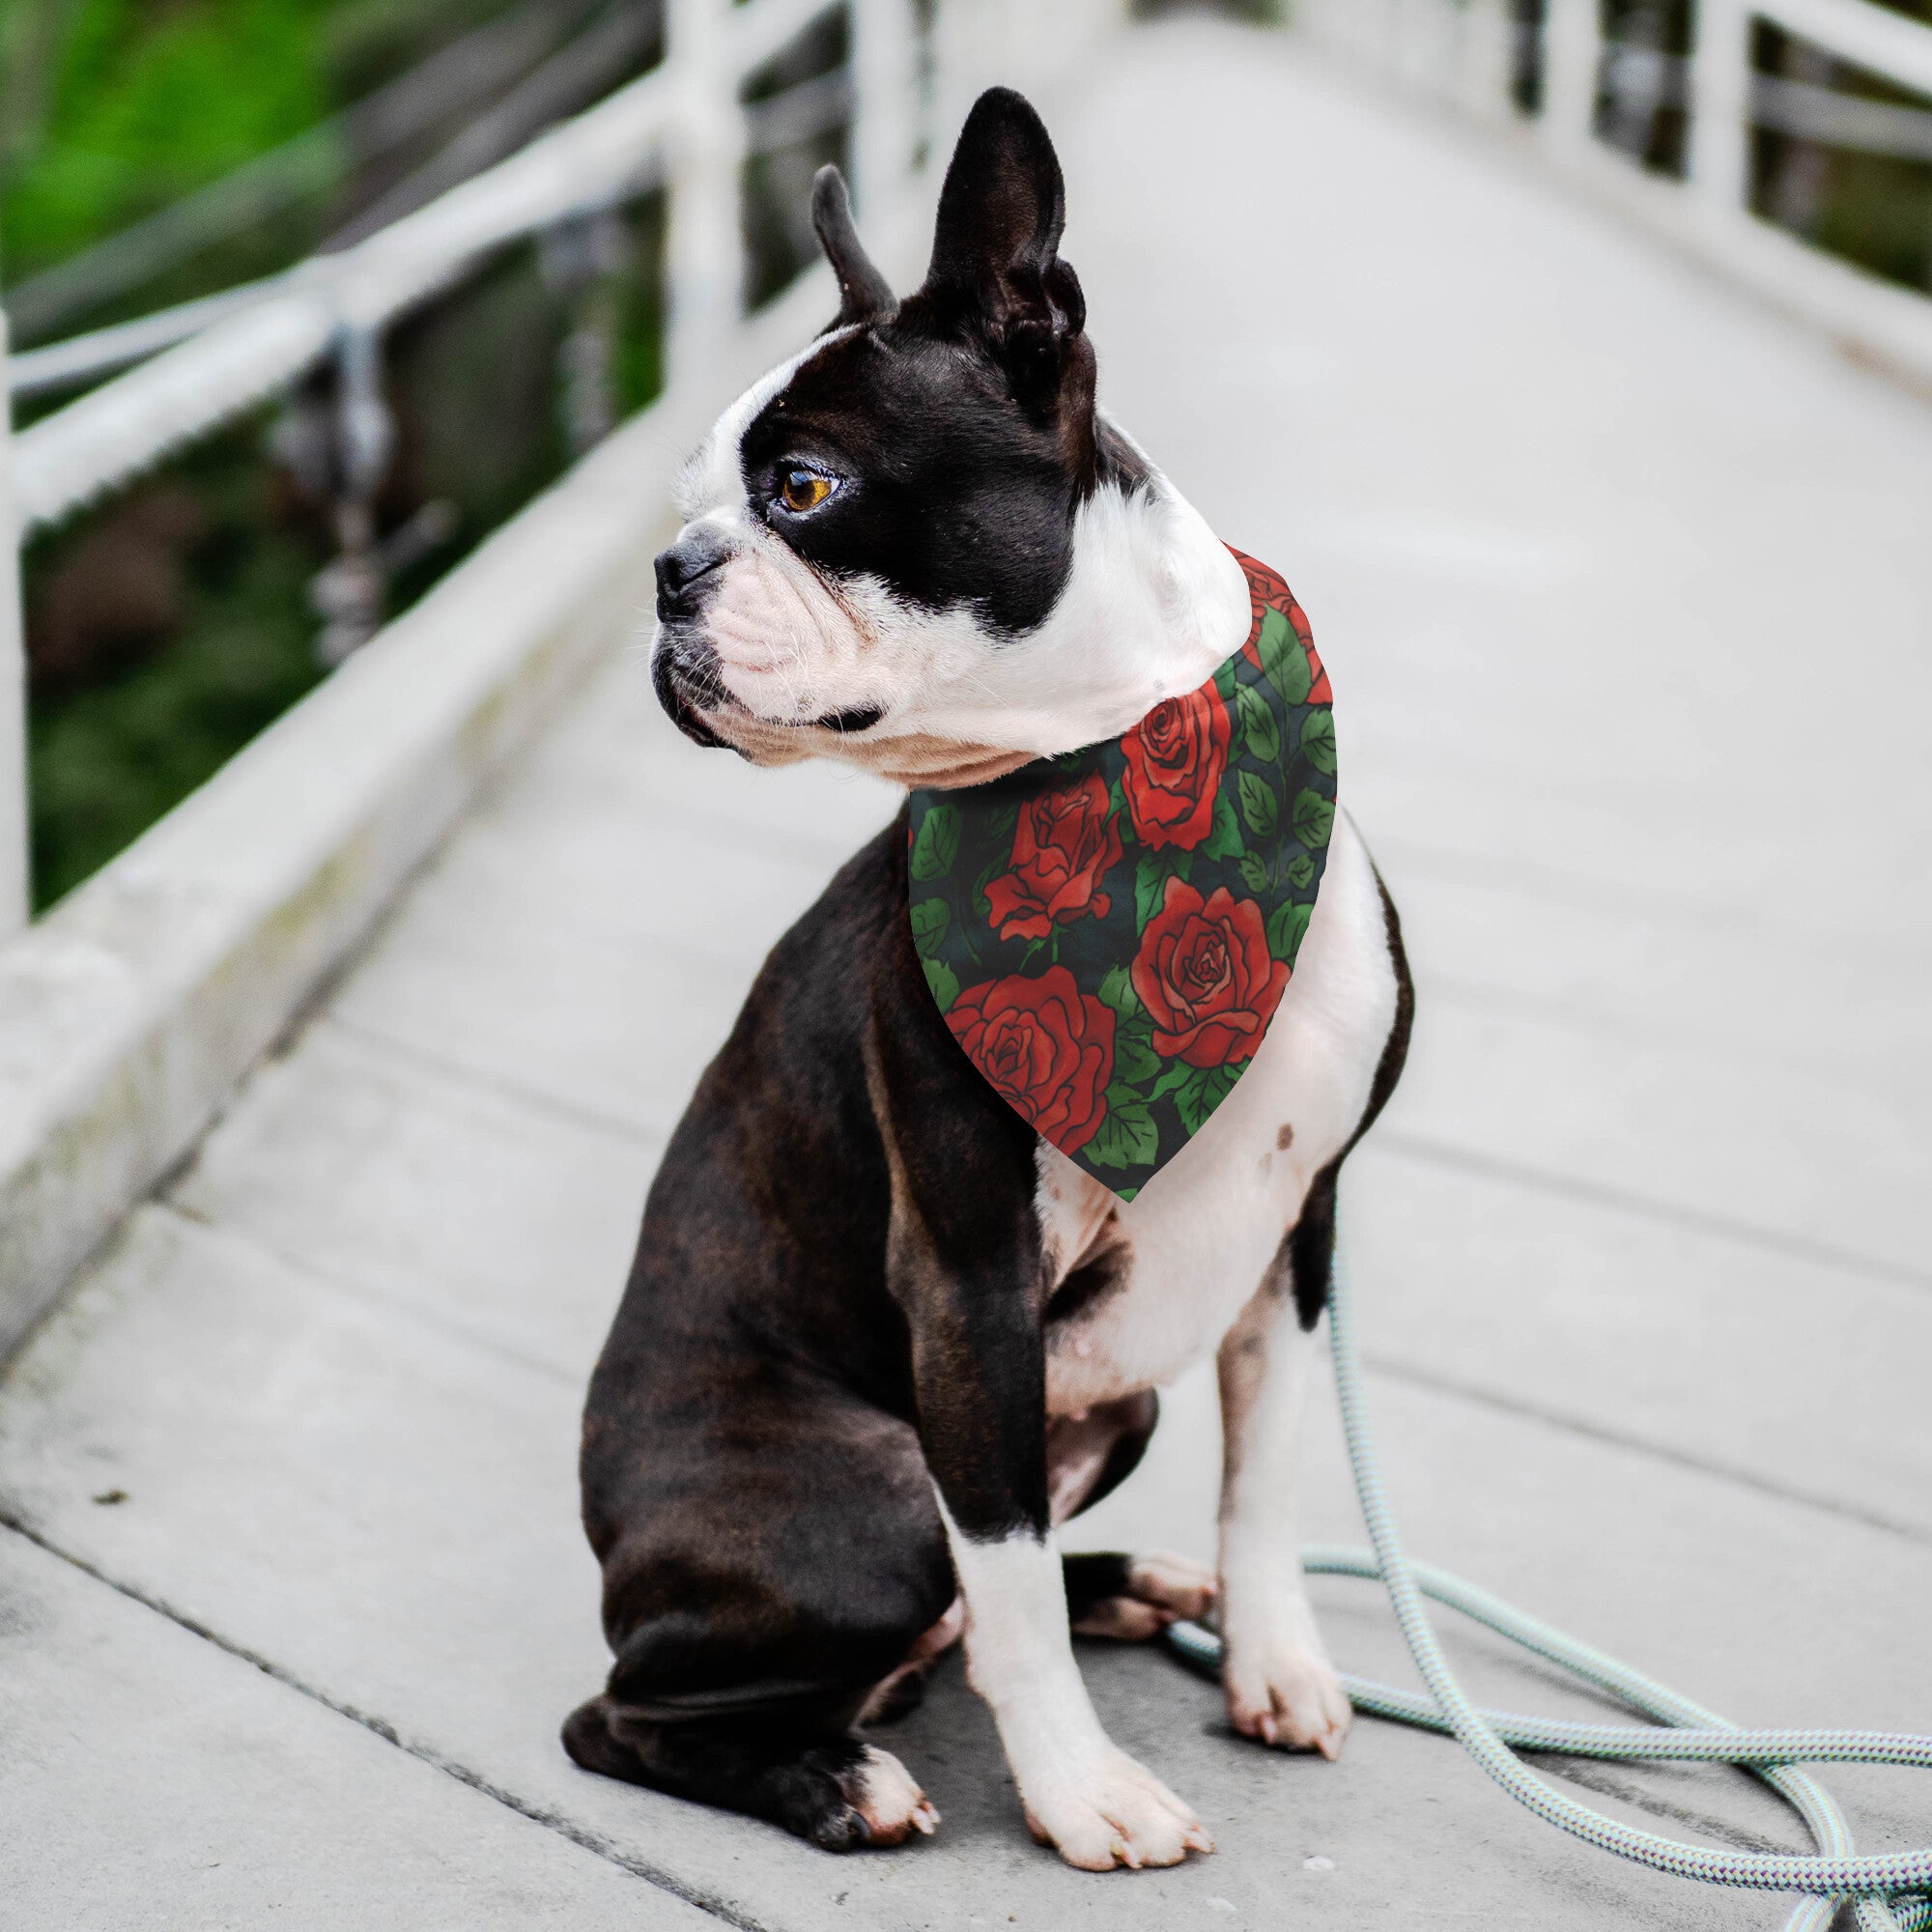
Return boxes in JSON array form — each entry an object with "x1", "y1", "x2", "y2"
[{"x1": 910, "y1": 551, "x2": 1335, "y2": 1200}]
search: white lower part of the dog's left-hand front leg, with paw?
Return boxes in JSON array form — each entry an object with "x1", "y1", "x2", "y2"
[{"x1": 939, "y1": 1499, "x2": 1213, "y2": 1872}]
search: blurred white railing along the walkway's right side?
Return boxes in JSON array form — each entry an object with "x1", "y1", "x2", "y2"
[{"x1": 1293, "y1": 0, "x2": 1932, "y2": 386}]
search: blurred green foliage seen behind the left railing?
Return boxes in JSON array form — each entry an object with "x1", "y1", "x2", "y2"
[{"x1": 0, "y1": 0, "x2": 663, "y2": 906}]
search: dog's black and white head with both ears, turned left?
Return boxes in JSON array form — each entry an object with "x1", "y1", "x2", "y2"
[{"x1": 653, "y1": 89, "x2": 1246, "y2": 784}]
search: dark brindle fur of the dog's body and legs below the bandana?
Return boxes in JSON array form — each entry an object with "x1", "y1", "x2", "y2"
[{"x1": 564, "y1": 815, "x2": 1153, "y2": 1849}]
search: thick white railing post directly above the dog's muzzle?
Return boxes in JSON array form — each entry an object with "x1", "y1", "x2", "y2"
[{"x1": 665, "y1": 0, "x2": 744, "y2": 390}]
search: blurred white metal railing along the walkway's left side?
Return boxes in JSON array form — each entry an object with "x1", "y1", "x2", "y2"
[{"x1": 0, "y1": 0, "x2": 989, "y2": 939}]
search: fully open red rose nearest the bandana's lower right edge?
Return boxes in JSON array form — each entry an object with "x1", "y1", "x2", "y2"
[{"x1": 1132, "y1": 875, "x2": 1289, "y2": 1066}]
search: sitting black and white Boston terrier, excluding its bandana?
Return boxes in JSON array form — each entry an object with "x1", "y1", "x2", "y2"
[{"x1": 564, "y1": 91, "x2": 1410, "y2": 1870}]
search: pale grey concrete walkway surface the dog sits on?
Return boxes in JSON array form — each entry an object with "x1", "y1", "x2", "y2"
[{"x1": 0, "y1": 23, "x2": 1932, "y2": 1932}]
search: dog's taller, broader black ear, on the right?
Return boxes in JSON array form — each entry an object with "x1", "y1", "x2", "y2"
[{"x1": 923, "y1": 87, "x2": 1086, "y2": 402}]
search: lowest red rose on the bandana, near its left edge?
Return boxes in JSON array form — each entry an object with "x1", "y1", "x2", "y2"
[{"x1": 947, "y1": 966, "x2": 1113, "y2": 1153}]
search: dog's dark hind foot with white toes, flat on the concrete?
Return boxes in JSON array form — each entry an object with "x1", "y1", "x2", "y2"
[{"x1": 564, "y1": 1694, "x2": 939, "y2": 1851}]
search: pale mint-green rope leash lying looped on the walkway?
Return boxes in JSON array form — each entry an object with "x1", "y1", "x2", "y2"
[{"x1": 1167, "y1": 1213, "x2": 1932, "y2": 1932}]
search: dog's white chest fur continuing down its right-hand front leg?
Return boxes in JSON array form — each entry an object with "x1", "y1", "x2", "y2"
[{"x1": 1036, "y1": 813, "x2": 1397, "y2": 1758}]
